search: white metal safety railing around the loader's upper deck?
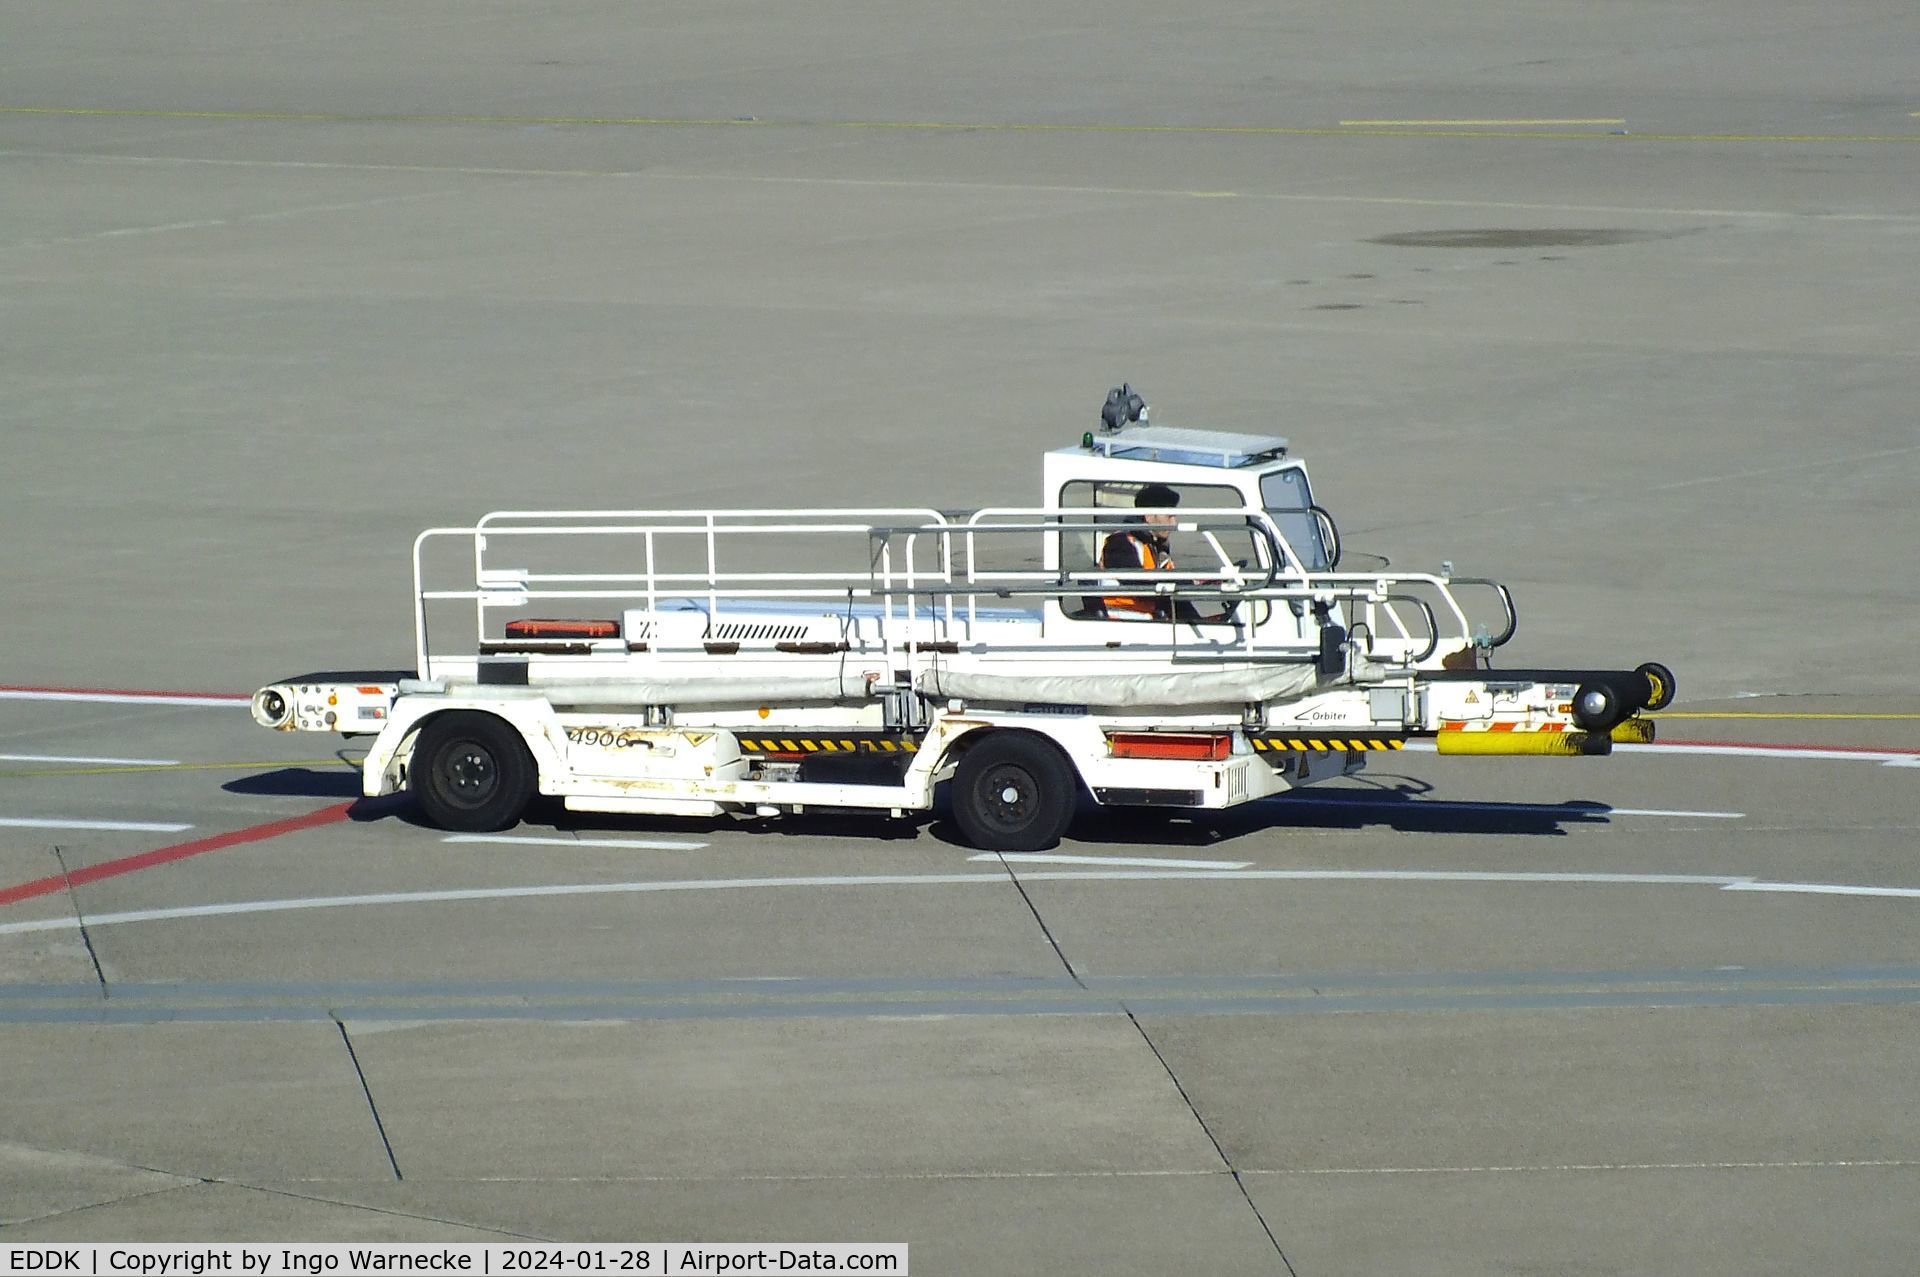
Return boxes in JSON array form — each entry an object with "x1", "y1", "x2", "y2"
[{"x1": 413, "y1": 507, "x2": 1517, "y2": 678}]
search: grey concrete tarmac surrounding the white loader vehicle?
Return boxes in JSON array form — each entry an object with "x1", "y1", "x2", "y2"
[{"x1": 0, "y1": 0, "x2": 1920, "y2": 1277}]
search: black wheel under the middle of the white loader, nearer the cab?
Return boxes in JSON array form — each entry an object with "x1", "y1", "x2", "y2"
[{"x1": 952, "y1": 732, "x2": 1079, "y2": 851}]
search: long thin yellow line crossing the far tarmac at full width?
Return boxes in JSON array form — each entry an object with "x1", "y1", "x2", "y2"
[{"x1": 11, "y1": 106, "x2": 1920, "y2": 144}]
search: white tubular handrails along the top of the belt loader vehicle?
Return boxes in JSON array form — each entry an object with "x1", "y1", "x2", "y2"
[{"x1": 411, "y1": 507, "x2": 1519, "y2": 676}]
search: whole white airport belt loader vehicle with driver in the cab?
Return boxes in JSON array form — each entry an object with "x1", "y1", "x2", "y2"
[{"x1": 253, "y1": 388, "x2": 1674, "y2": 851}]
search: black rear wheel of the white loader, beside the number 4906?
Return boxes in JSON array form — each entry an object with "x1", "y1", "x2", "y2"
[{"x1": 407, "y1": 711, "x2": 540, "y2": 833}]
